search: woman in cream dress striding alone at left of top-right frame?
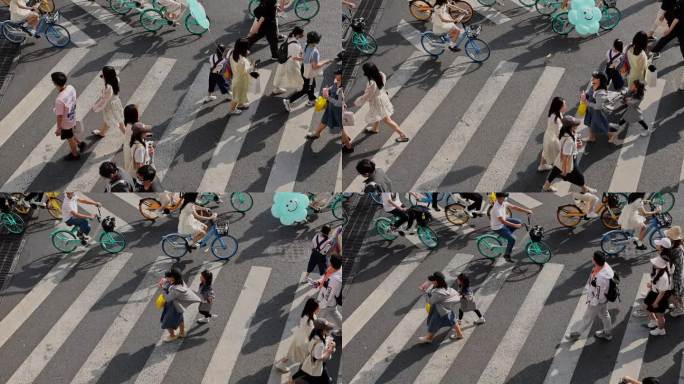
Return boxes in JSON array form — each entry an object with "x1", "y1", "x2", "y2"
[{"x1": 354, "y1": 62, "x2": 409, "y2": 143}]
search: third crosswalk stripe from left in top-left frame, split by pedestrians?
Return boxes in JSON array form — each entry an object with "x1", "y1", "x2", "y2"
[{"x1": 65, "y1": 57, "x2": 176, "y2": 191}]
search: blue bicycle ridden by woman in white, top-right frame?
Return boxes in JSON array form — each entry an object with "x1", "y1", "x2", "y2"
[{"x1": 420, "y1": 24, "x2": 491, "y2": 63}]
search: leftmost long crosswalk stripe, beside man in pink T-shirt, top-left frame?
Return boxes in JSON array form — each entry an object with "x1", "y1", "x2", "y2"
[{"x1": 0, "y1": 48, "x2": 89, "y2": 150}]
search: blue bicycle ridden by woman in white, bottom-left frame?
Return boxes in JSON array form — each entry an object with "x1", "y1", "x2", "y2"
[{"x1": 161, "y1": 220, "x2": 238, "y2": 260}]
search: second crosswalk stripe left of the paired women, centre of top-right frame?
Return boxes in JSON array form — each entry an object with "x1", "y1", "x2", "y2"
[{"x1": 411, "y1": 61, "x2": 518, "y2": 191}]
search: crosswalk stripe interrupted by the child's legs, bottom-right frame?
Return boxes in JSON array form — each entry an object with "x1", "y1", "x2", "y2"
[{"x1": 413, "y1": 258, "x2": 514, "y2": 384}]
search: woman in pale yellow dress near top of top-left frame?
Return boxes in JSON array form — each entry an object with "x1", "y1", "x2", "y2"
[{"x1": 272, "y1": 26, "x2": 304, "y2": 95}]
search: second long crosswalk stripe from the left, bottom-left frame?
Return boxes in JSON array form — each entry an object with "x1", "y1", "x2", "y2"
[{"x1": 7, "y1": 252, "x2": 133, "y2": 384}]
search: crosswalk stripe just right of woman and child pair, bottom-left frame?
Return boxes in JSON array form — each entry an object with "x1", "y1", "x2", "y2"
[{"x1": 202, "y1": 267, "x2": 271, "y2": 384}]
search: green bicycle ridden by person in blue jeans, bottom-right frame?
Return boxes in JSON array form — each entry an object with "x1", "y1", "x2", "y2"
[{"x1": 477, "y1": 215, "x2": 552, "y2": 264}]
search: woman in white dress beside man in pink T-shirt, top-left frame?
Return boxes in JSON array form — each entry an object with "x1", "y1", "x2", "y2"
[{"x1": 93, "y1": 66, "x2": 125, "y2": 138}]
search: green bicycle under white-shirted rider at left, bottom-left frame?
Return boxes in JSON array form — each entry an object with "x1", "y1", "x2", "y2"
[{"x1": 50, "y1": 207, "x2": 126, "y2": 254}]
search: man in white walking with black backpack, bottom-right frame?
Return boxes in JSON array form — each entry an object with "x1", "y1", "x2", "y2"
[{"x1": 565, "y1": 251, "x2": 618, "y2": 341}]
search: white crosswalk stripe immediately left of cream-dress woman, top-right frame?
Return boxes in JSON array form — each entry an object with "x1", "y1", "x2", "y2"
[{"x1": 475, "y1": 67, "x2": 565, "y2": 191}]
